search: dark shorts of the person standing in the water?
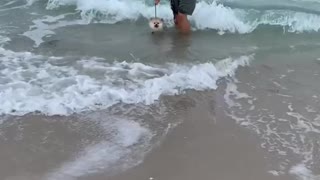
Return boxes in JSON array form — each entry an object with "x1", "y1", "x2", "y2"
[{"x1": 171, "y1": 0, "x2": 197, "y2": 16}]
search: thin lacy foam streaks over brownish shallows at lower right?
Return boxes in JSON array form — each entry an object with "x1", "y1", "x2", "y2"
[{"x1": 224, "y1": 77, "x2": 320, "y2": 180}]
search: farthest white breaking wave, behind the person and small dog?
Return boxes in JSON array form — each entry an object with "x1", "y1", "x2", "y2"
[{"x1": 38, "y1": 0, "x2": 320, "y2": 33}]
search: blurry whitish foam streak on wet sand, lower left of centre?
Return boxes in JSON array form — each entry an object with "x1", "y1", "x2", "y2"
[{"x1": 44, "y1": 119, "x2": 152, "y2": 180}]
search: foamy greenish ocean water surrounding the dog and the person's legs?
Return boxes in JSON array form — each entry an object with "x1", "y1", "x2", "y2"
[{"x1": 0, "y1": 0, "x2": 320, "y2": 180}]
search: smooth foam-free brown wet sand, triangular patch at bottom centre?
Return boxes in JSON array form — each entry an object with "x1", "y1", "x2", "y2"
[{"x1": 108, "y1": 91, "x2": 294, "y2": 180}]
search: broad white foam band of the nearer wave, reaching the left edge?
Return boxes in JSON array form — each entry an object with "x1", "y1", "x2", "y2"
[{"x1": 0, "y1": 48, "x2": 253, "y2": 115}]
